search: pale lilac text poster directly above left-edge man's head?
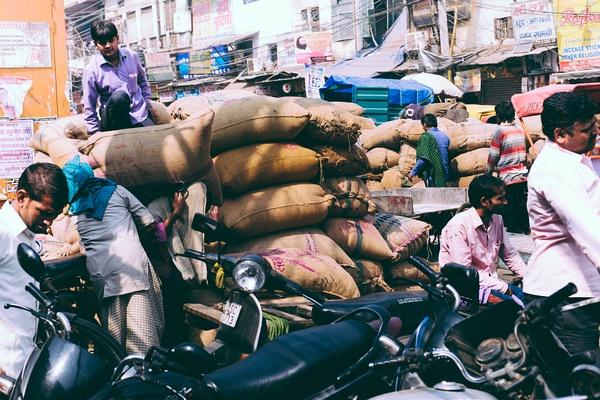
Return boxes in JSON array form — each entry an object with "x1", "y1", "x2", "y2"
[{"x1": 0, "y1": 120, "x2": 33, "y2": 178}]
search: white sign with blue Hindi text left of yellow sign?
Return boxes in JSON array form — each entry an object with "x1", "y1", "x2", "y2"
[{"x1": 512, "y1": 0, "x2": 556, "y2": 43}]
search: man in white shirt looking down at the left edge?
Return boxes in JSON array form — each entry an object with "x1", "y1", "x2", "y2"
[{"x1": 0, "y1": 163, "x2": 67, "y2": 378}]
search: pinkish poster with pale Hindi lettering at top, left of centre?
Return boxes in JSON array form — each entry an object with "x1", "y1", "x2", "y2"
[{"x1": 192, "y1": 0, "x2": 233, "y2": 50}]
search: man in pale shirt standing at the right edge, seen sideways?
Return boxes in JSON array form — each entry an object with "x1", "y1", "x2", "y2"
[{"x1": 523, "y1": 92, "x2": 600, "y2": 353}]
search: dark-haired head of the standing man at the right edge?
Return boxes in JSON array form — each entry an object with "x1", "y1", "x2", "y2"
[{"x1": 542, "y1": 92, "x2": 598, "y2": 154}]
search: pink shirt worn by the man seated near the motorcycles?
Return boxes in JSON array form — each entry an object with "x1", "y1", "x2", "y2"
[{"x1": 439, "y1": 207, "x2": 525, "y2": 300}]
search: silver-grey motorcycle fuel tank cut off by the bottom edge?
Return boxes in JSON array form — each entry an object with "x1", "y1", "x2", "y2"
[{"x1": 371, "y1": 382, "x2": 497, "y2": 400}]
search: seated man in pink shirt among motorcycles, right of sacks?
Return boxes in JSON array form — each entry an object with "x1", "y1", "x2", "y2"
[{"x1": 439, "y1": 175, "x2": 525, "y2": 303}]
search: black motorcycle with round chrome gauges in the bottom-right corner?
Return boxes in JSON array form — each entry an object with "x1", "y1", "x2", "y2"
[{"x1": 371, "y1": 258, "x2": 600, "y2": 400}]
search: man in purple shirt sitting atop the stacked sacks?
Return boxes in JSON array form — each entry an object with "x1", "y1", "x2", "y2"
[{"x1": 82, "y1": 21, "x2": 154, "y2": 135}]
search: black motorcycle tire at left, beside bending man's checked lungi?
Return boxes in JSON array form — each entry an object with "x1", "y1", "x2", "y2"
[{"x1": 65, "y1": 314, "x2": 128, "y2": 367}]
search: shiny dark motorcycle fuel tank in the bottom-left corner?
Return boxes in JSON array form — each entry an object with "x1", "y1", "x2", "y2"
[{"x1": 11, "y1": 336, "x2": 112, "y2": 400}]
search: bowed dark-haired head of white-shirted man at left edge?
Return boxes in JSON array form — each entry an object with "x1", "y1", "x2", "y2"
[{"x1": 12, "y1": 163, "x2": 68, "y2": 233}]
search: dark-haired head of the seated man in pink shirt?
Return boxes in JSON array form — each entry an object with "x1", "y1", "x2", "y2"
[{"x1": 469, "y1": 174, "x2": 508, "y2": 215}]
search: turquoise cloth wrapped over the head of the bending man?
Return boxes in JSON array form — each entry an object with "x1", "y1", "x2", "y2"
[{"x1": 63, "y1": 156, "x2": 117, "y2": 221}]
